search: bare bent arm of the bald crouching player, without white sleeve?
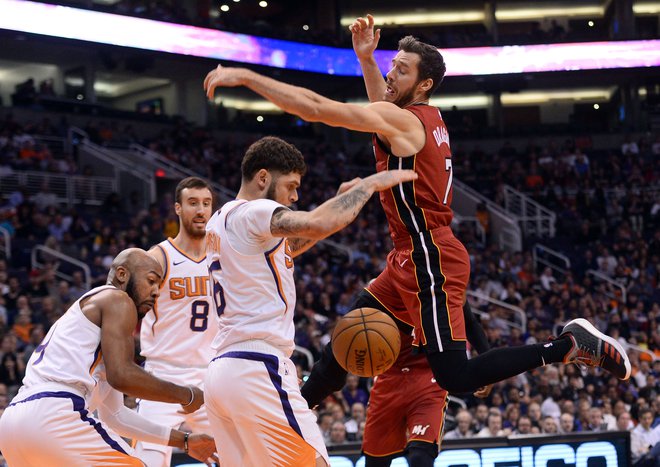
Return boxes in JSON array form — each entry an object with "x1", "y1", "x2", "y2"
[{"x1": 96, "y1": 291, "x2": 204, "y2": 413}]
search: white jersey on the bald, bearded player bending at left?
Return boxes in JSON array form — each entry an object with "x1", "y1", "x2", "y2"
[{"x1": 22, "y1": 285, "x2": 115, "y2": 398}]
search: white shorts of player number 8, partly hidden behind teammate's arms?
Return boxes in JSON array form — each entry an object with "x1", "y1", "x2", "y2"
[{"x1": 135, "y1": 360, "x2": 211, "y2": 465}]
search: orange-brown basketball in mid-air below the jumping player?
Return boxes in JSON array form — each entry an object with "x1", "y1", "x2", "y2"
[{"x1": 332, "y1": 308, "x2": 401, "y2": 377}]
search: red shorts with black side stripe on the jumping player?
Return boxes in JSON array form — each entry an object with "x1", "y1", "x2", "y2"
[{"x1": 367, "y1": 227, "x2": 470, "y2": 353}]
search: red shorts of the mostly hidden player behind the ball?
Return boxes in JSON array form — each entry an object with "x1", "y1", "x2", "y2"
[{"x1": 362, "y1": 366, "x2": 447, "y2": 457}]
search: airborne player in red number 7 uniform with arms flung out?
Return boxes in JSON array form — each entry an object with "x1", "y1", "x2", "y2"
[{"x1": 204, "y1": 15, "x2": 631, "y2": 403}]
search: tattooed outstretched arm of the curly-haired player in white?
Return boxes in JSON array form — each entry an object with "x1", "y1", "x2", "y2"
[{"x1": 270, "y1": 170, "x2": 417, "y2": 240}]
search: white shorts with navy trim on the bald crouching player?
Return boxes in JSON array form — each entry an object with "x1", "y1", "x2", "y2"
[{"x1": 0, "y1": 390, "x2": 144, "y2": 467}]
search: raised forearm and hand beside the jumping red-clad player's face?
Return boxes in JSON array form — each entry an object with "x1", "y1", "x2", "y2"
[{"x1": 348, "y1": 15, "x2": 386, "y2": 102}]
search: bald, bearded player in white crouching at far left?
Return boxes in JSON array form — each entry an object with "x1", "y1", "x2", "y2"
[{"x1": 0, "y1": 248, "x2": 204, "y2": 467}]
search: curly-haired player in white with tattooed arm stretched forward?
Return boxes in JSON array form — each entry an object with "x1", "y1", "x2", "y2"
[{"x1": 204, "y1": 137, "x2": 416, "y2": 467}]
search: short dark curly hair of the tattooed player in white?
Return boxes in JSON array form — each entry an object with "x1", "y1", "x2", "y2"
[{"x1": 241, "y1": 136, "x2": 307, "y2": 181}]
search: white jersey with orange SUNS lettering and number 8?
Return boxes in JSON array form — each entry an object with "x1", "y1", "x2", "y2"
[{"x1": 140, "y1": 239, "x2": 218, "y2": 368}]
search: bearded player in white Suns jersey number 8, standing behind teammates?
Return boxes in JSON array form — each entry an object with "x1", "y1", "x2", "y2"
[{"x1": 136, "y1": 177, "x2": 218, "y2": 467}]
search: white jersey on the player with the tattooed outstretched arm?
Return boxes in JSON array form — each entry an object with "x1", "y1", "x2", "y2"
[{"x1": 206, "y1": 199, "x2": 296, "y2": 355}]
